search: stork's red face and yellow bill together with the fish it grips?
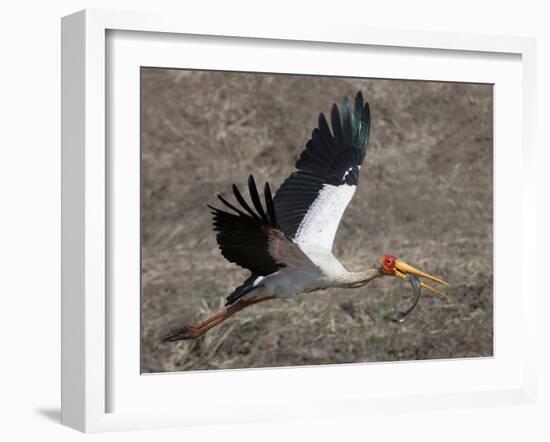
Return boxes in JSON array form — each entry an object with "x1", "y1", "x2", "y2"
[{"x1": 380, "y1": 255, "x2": 449, "y2": 322}]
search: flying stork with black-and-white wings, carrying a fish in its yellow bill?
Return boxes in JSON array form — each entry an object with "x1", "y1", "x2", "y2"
[{"x1": 163, "y1": 92, "x2": 448, "y2": 341}]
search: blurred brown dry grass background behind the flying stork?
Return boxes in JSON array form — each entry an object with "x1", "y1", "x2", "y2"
[{"x1": 141, "y1": 68, "x2": 493, "y2": 372}]
